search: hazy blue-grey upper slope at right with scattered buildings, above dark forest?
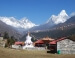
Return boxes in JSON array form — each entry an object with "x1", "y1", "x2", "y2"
[{"x1": 52, "y1": 16, "x2": 75, "y2": 29}]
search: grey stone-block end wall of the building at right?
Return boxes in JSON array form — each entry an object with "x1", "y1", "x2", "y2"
[{"x1": 57, "y1": 39, "x2": 75, "y2": 54}]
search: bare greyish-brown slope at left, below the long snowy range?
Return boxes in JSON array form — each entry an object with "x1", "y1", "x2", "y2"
[{"x1": 0, "y1": 21, "x2": 22, "y2": 39}]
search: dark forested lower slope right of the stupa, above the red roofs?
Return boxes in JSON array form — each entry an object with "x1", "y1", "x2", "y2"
[{"x1": 29, "y1": 28, "x2": 75, "y2": 38}]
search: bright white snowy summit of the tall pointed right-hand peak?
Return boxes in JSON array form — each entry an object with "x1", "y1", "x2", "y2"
[{"x1": 47, "y1": 10, "x2": 69, "y2": 24}]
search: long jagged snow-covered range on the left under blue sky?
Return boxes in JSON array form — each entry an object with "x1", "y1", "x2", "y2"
[{"x1": 0, "y1": 17, "x2": 36, "y2": 29}]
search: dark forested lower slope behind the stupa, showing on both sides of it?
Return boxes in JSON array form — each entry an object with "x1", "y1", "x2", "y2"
[{"x1": 22, "y1": 28, "x2": 75, "y2": 40}]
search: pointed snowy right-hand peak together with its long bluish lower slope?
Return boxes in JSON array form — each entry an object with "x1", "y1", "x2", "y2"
[{"x1": 27, "y1": 10, "x2": 69, "y2": 32}]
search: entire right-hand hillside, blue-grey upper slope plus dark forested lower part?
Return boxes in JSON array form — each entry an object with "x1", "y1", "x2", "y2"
[{"x1": 22, "y1": 16, "x2": 75, "y2": 40}]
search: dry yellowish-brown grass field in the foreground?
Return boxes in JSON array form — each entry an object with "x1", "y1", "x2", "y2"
[{"x1": 0, "y1": 47, "x2": 75, "y2": 58}]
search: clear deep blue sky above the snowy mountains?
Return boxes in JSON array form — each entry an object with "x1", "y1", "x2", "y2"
[{"x1": 0, "y1": 0, "x2": 75, "y2": 24}]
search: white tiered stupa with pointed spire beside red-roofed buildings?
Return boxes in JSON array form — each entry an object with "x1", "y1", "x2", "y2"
[{"x1": 23, "y1": 32, "x2": 34, "y2": 49}]
